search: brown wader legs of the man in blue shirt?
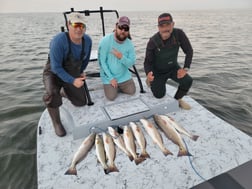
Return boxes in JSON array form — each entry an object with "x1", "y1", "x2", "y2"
[{"x1": 43, "y1": 71, "x2": 87, "y2": 108}]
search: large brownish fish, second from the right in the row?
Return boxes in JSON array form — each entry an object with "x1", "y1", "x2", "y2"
[{"x1": 153, "y1": 115, "x2": 191, "y2": 156}]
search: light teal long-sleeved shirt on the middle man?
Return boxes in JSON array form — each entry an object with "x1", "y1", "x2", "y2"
[{"x1": 98, "y1": 33, "x2": 136, "y2": 84}]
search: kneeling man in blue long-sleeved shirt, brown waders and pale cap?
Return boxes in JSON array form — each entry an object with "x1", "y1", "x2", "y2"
[{"x1": 43, "y1": 12, "x2": 92, "y2": 136}]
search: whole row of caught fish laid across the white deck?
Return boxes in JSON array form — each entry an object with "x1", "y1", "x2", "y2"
[{"x1": 65, "y1": 115, "x2": 199, "y2": 175}]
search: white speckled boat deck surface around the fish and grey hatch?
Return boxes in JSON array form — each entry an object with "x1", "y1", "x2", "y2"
[{"x1": 37, "y1": 78, "x2": 252, "y2": 189}]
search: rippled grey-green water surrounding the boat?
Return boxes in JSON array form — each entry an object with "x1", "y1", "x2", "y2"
[{"x1": 0, "y1": 10, "x2": 252, "y2": 189}]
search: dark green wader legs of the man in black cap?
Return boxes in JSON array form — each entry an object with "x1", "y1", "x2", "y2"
[{"x1": 151, "y1": 67, "x2": 193, "y2": 100}]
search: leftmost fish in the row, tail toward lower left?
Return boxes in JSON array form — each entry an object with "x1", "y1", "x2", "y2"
[{"x1": 65, "y1": 133, "x2": 95, "y2": 175}]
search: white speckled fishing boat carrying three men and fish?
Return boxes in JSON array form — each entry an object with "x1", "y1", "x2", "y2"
[{"x1": 37, "y1": 7, "x2": 252, "y2": 189}]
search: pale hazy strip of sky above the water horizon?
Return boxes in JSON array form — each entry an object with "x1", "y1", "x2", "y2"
[{"x1": 0, "y1": 0, "x2": 252, "y2": 13}]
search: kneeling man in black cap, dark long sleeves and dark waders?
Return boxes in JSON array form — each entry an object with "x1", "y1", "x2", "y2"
[{"x1": 144, "y1": 13, "x2": 193, "y2": 110}]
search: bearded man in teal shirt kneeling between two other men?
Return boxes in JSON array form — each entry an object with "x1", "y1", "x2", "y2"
[{"x1": 98, "y1": 16, "x2": 136, "y2": 100}]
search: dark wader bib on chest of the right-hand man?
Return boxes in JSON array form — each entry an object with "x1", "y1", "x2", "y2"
[{"x1": 151, "y1": 28, "x2": 180, "y2": 73}]
